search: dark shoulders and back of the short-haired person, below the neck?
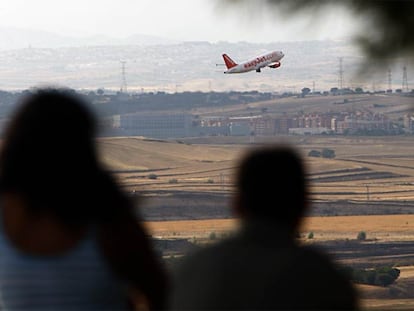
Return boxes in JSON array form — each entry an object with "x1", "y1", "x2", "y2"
[{"x1": 171, "y1": 228, "x2": 357, "y2": 310}]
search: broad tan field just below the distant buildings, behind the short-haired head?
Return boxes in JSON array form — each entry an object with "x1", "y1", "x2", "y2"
[{"x1": 99, "y1": 136, "x2": 414, "y2": 202}]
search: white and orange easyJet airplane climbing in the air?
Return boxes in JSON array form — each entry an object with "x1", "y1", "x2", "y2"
[{"x1": 222, "y1": 51, "x2": 285, "y2": 73}]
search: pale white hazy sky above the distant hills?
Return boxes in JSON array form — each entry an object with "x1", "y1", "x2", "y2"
[{"x1": 0, "y1": 0, "x2": 355, "y2": 42}]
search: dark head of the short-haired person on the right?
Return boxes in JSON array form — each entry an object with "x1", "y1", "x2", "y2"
[{"x1": 236, "y1": 146, "x2": 307, "y2": 229}]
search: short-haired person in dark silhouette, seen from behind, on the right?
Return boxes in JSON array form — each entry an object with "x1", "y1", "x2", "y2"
[{"x1": 171, "y1": 146, "x2": 357, "y2": 310}]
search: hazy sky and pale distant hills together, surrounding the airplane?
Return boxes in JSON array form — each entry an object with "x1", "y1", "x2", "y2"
[{"x1": 0, "y1": 0, "x2": 413, "y2": 93}]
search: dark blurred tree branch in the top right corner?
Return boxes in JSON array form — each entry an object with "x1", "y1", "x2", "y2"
[{"x1": 217, "y1": 0, "x2": 414, "y2": 62}]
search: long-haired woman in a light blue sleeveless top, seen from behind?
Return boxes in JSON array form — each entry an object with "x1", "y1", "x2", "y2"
[{"x1": 0, "y1": 89, "x2": 166, "y2": 310}]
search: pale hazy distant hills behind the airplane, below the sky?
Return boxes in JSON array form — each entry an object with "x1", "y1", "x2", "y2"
[{"x1": 0, "y1": 29, "x2": 413, "y2": 92}]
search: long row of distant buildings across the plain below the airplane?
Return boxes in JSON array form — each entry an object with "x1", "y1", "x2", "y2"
[{"x1": 105, "y1": 111, "x2": 402, "y2": 138}]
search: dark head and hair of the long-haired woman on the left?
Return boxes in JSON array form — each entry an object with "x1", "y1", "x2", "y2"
[{"x1": 0, "y1": 89, "x2": 116, "y2": 225}]
